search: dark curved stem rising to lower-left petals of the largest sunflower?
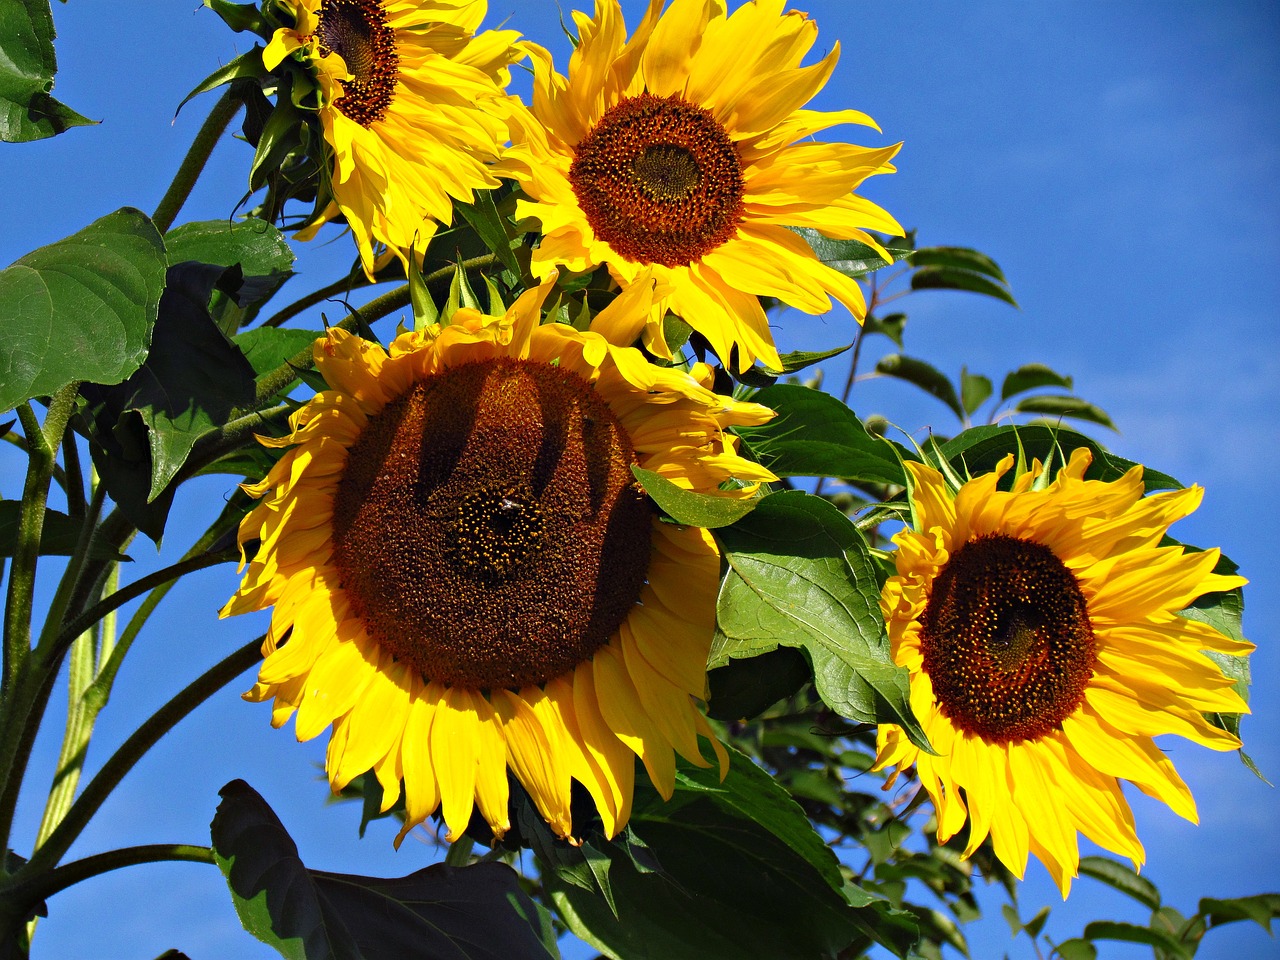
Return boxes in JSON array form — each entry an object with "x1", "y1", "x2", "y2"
[{"x1": 19, "y1": 636, "x2": 265, "y2": 876}]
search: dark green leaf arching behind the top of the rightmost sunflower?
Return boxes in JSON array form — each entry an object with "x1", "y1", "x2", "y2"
[{"x1": 941, "y1": 424, "x2": 1183, "y2": 493}]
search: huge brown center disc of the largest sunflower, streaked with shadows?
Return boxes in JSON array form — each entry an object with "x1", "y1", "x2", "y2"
[{"x1": 333, "y1": 357, "x2": 652, "y2": 690}]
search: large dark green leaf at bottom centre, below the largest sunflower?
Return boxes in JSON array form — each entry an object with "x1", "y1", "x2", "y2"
[{"x1": 544, "y1": 751, "x2": 915, "y2": 960}]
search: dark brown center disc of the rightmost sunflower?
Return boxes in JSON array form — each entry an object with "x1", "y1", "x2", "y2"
[{"x1": 920, "y1": 534, "x2": 1096, "y2": 744}]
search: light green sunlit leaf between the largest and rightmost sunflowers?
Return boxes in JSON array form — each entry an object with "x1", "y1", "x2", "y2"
[{"x1": 708, "y1": 490, "x2": 929, "y2": 750}]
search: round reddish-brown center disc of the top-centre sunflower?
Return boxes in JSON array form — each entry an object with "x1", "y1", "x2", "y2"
[{"x1": 568, "y1": 93, "x2": 744, "y2": 266}]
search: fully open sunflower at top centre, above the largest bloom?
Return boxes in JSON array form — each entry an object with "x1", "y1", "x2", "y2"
[{"x1": 500, "y1": 0, "x2": 902, "y2": 370}]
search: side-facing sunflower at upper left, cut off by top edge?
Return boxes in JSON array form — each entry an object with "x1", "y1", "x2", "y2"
[{"x1": 262, "y1": 0, "x2": 522, "y2": 275}]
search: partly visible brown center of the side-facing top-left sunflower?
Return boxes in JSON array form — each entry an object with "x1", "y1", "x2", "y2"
[{"x1": 316, "y1": 0, "x2": 399, "y2": 127}]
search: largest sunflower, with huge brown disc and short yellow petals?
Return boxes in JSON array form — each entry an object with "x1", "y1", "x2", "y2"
[{"x1": 223, "y1": 278, "x2": 774, "y2": 842}]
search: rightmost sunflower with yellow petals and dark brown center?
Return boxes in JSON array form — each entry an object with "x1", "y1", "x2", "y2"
[{"x1": 876, "y1": 448, "x2": 1253, "y2": 897}]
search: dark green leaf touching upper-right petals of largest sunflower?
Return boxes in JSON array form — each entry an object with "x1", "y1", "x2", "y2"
[{"x1": 737, "y1": 384, "x2": 909, "y2": 486}]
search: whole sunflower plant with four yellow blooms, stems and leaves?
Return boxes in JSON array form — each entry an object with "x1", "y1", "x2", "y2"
[{"x1": 0, "y1": 0, "x2": 1280, "y2": 960}]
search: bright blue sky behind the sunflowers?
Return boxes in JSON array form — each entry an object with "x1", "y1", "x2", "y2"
[{"x1": 0, "y1": 0, "x2": 1280, "y2": 960}]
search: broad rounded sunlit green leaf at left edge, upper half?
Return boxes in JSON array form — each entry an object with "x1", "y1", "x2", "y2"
[{"x1": 0, "y1": 207, "x2": 165, "y2": 411}]
